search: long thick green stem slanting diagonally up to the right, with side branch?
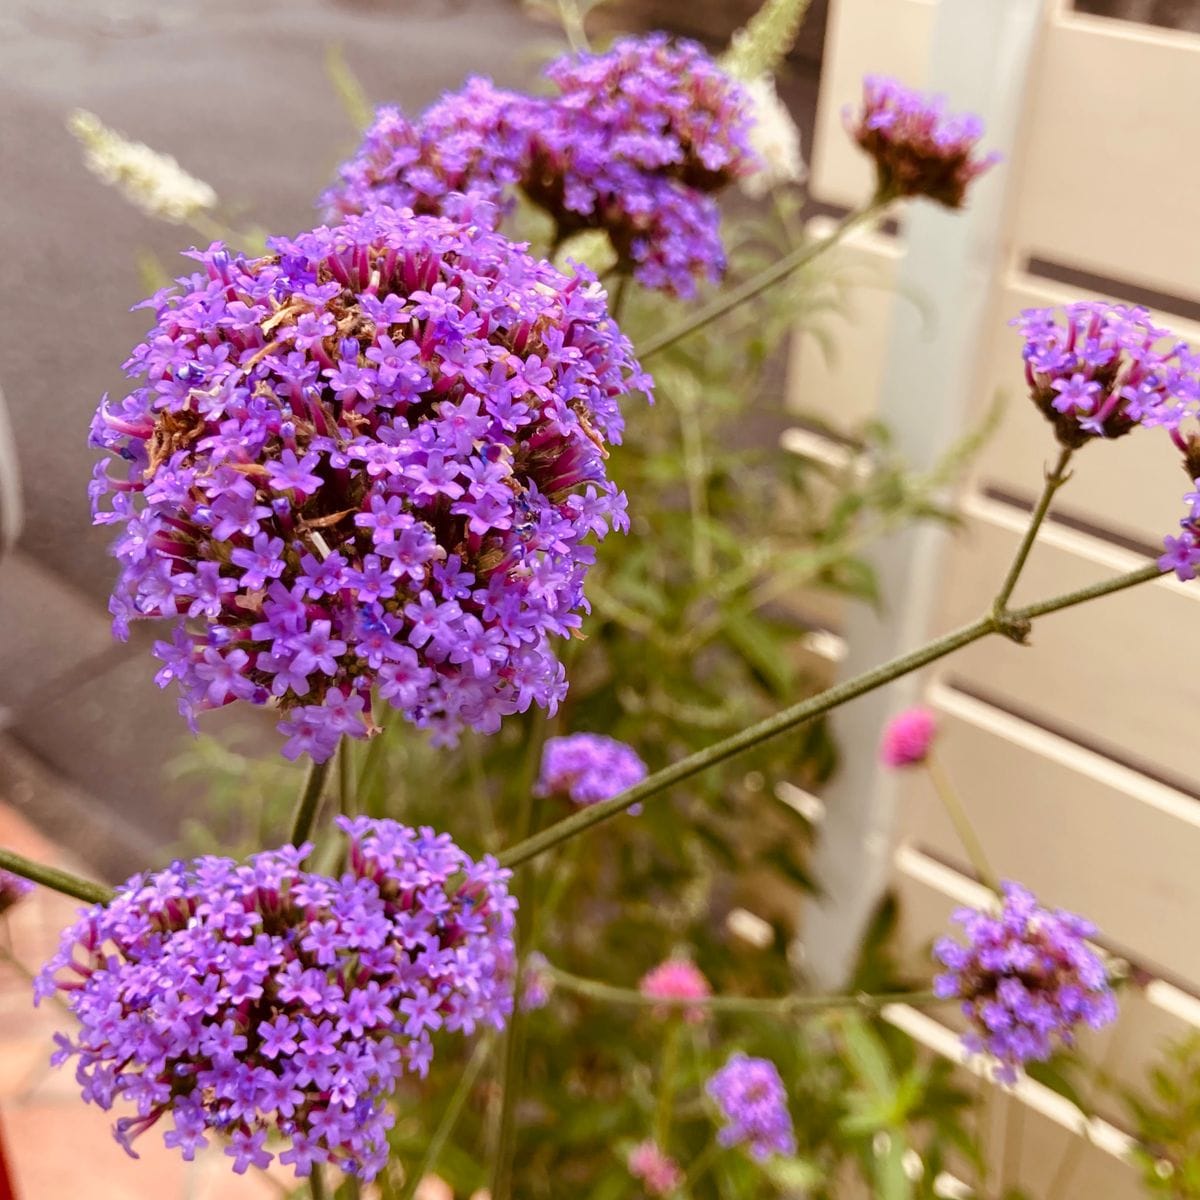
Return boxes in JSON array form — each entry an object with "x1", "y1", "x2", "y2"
[{"x1": 498, "y1": 563, "x2": 1163, "y2": 866}]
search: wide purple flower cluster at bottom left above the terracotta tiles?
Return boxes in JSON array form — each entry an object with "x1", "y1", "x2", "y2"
[{"x1": 36, "y1": 817, "x2": 516, "y2": 1180}]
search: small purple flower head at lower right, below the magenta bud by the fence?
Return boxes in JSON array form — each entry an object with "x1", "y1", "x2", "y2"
[{"x1": 934, "y1": 883, "x2": 1117, "y2": 1084}]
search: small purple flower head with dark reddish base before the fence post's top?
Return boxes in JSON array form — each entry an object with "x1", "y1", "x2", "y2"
[{"x1": 845, "y1": 76, "x2": 1000, "y2": 209}]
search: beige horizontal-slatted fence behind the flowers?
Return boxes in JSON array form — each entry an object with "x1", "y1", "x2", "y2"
[{"x1": 788, "y1": 0, "x2": 1200, "y2": 1200}]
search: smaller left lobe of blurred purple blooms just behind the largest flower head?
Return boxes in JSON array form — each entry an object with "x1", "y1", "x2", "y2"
[{"x1": 320, "y1": 77, "x2": 545, "y2": 220}]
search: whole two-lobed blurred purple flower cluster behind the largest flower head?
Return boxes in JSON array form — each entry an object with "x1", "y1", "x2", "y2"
[{"x1": 322, "y1": 34, "x2": 757, "y2": 295}]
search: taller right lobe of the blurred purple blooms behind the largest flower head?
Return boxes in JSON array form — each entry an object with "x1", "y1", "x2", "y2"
[{"x1": 522, "y1": 34, "x2": 757, "y2": 296}]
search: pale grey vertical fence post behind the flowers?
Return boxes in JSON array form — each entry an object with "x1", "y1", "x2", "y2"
[{"x1": 803, "y1": 0, "x2": 1051, "y2": 986}]
